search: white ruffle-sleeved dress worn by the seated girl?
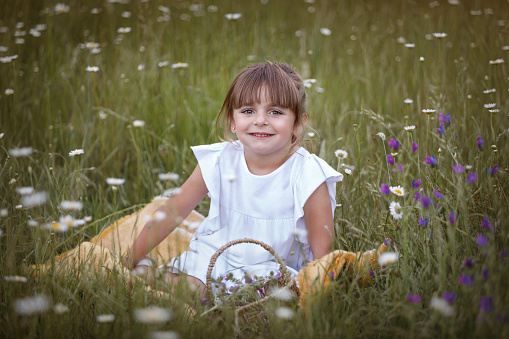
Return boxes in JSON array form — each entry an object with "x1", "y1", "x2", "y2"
[{"x1": 168, "y1": 141, "x2": 343, "y2": 284}]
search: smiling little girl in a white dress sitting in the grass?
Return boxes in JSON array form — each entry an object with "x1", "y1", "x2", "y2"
[{"x1": 124, "y1": 62, "x2": 343, "y2": 294}]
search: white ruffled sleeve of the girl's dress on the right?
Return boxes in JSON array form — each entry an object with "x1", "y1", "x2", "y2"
[{"x1": 292, "y1": 154, "x2": 343, "y2": 244}]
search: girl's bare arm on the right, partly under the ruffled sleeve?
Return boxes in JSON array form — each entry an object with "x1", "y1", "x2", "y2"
[{"x1": 304, "y1": 182, "x2": 334, "y2": 259}]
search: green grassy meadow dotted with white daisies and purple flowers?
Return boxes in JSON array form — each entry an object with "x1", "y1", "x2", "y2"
[{"x1": 0, "y1": 0, "x2": 509, "y2": 338}]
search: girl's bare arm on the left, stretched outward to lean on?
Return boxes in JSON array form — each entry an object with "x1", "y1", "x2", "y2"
[{"x1": 124, "y1": 165, "x2": 208, "y2": 269}]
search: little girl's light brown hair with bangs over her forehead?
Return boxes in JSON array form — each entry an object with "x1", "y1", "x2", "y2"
[{"x1": 216, "y1": 61, "x2": 306, "y2": 145}]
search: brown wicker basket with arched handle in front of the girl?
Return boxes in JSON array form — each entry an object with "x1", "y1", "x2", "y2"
[{"x1": 206, "y1": 238, "x2": 298, "y2": 329}]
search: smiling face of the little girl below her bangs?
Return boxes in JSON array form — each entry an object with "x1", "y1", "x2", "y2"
[{"x1": 231, "y1": 88, "x2": 298, "y2": 159}]
